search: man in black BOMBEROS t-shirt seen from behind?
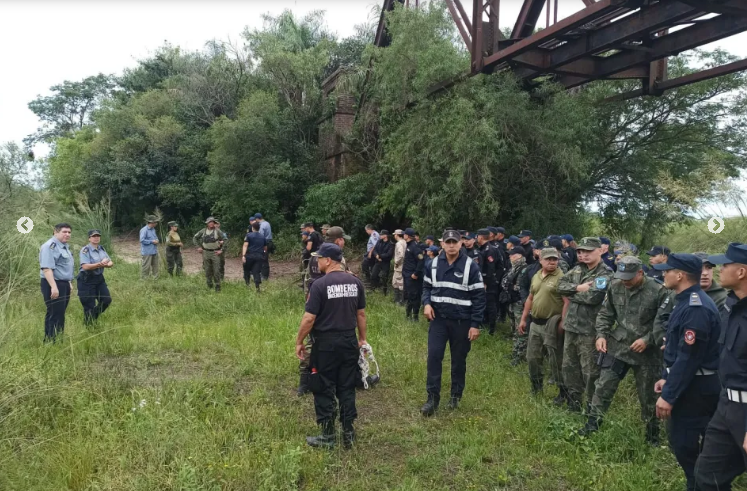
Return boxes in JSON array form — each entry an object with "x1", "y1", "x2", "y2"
[{"x1": 296, "y1": 243, "x2": 366, "y2": 448}]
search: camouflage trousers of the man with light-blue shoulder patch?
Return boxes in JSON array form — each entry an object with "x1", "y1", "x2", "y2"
[{"x1": 563, "y1": 331, "x2": 599, "y2": 403}]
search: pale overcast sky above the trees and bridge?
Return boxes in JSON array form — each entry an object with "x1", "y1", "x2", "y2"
[{"x1": 0, "y1": 0, "x2": 747, "y2": 159}]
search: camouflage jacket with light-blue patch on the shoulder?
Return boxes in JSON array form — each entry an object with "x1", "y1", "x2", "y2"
[{"x1": 558, "y1": 261, "x2": 613, "y2": 336}]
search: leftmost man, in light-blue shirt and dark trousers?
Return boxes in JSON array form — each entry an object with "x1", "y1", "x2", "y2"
[{"x1": 39, "y1": 223, "x2": 75, "y2": 342}]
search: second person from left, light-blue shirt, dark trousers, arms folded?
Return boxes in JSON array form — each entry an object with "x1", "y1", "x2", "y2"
[{"x1": 77, "y1": 229, "x2": 114, "y2": 326}]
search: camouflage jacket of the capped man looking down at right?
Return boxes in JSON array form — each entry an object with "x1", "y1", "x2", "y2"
[{"x1": 597, "y1": 276, "x2": 672, "y2": 365}]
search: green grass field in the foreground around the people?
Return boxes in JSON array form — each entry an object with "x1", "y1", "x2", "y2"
[{"x1": 0, "y1": 262, "x2": 745, "y2": 491}]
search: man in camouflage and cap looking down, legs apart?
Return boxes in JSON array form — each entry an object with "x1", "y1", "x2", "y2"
[{"x1": 579, "y1": 256, "x2": 672, "y2": 446}]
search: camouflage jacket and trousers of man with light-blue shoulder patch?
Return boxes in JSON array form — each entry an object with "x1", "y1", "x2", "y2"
[{"x1": 558, "y1": 256, "x2": 612, "y2": 409}]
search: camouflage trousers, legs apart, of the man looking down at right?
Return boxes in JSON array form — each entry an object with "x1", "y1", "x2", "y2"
[{"x1": 591, "y1": 365, "x2": 661, "y2": 423}]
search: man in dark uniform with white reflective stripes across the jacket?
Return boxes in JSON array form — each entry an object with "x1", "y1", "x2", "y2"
[{"x1": 420, "y1": 230, "x2": 485, "y2": 416}]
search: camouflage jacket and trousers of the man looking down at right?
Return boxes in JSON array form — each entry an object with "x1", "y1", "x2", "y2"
[{"x1": 591, "y1": 272, "x2": 673, "y2": 426}]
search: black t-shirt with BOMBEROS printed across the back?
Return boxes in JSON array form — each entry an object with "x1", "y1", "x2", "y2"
[{"x1": 306, "y1": 271, "x2": 366, "y2": 333}]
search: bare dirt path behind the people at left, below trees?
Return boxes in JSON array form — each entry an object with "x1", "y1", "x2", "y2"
[{"x1": 112, "y1": 235, "x2": 299, "y2": 280}]
